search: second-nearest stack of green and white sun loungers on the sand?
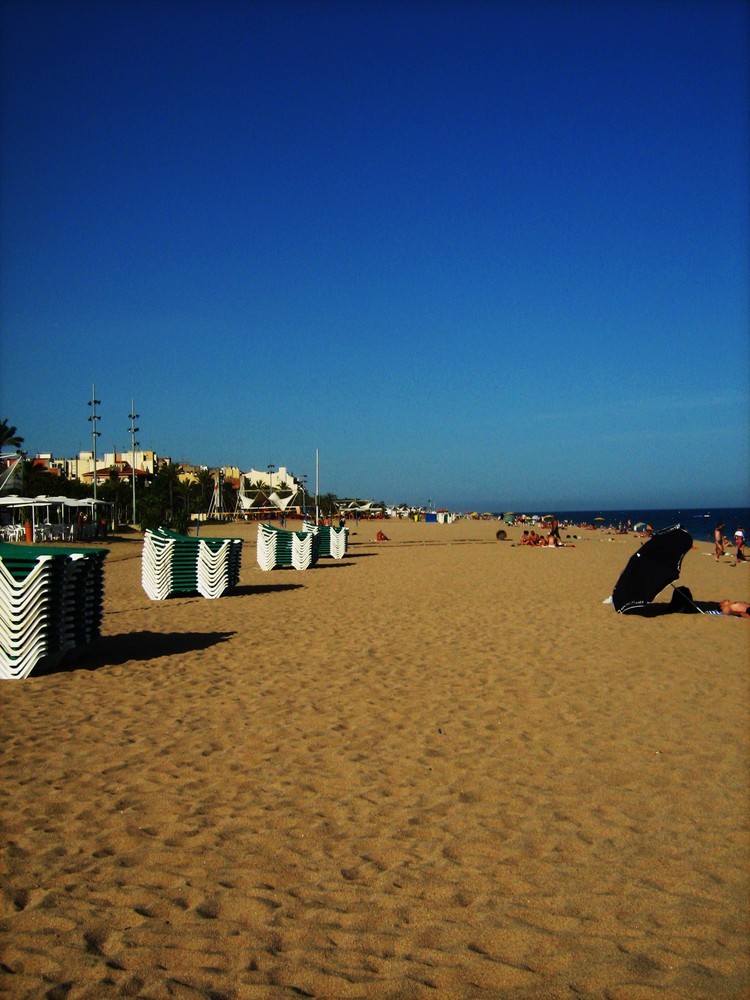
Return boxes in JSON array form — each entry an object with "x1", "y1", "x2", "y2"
[{"x1": 141, "y1": 528, "x2": 242, "y2": 601}]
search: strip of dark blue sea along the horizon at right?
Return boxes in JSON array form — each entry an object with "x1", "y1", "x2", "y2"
[{"x1": 499, "y1": 507, "x2": 750, "y2": 542}]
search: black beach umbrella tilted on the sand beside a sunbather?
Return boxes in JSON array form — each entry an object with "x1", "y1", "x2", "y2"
[{"x1": 612, "y1": 524, "x2": 693, "y2": 614}]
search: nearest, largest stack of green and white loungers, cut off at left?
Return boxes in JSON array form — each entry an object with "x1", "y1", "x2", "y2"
[{"x1": 0, "y1": 543, "x2": 108, "y2": 680}]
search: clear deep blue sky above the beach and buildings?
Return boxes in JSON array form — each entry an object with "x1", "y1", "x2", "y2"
[{"x1": 0, "y1": 0, "x2": 750, "y2": 510}]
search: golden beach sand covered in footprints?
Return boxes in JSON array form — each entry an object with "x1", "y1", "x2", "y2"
[{"x1": 0, "y1": 521, "x2": 750, "y2": 1000}]
